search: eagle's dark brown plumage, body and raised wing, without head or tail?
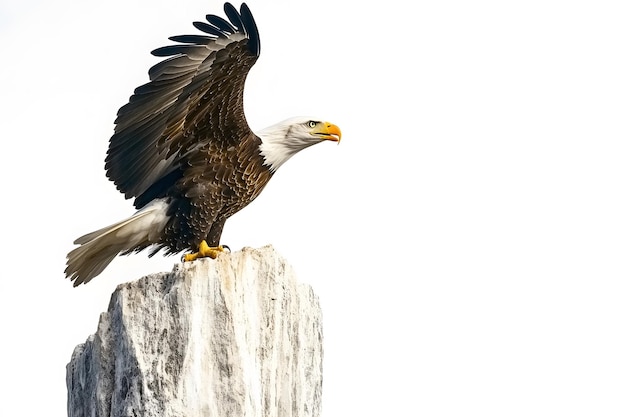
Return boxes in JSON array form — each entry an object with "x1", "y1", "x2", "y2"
[{"x1": 106, "y1": 5, "x2": 264, "y2": 253}]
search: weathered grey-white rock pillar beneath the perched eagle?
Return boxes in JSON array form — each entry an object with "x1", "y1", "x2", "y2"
[{"x1": 67, "y1": 246, "x2": 322, "y2": 417}]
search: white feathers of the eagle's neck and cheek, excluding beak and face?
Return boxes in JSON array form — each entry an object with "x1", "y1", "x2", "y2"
[{"x1": 256, "y1": 120, "x2": 316, "y2": 172}]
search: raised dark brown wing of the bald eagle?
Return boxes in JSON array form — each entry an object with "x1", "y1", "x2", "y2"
[{"x1": 105, "y1": 3, "x2": 260, "y2": 208}]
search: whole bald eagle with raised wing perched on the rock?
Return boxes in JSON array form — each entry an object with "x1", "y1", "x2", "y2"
[{"x1": 65, "y1": 3, "x2": 341, "y2": 286}]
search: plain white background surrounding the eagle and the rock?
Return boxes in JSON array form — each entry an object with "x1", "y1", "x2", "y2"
[{"x1": 0, "y1": 0, "x2": 626, "y2": 417}]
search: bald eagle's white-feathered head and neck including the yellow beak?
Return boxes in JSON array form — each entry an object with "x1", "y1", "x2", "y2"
[{"x1": 256, "y1": 117, "x2": 341, "y2": 172}]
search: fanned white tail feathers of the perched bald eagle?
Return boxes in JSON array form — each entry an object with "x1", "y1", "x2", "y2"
[{"x1": 65, "y1": 200, "x2": 168, "y2": 286}]
